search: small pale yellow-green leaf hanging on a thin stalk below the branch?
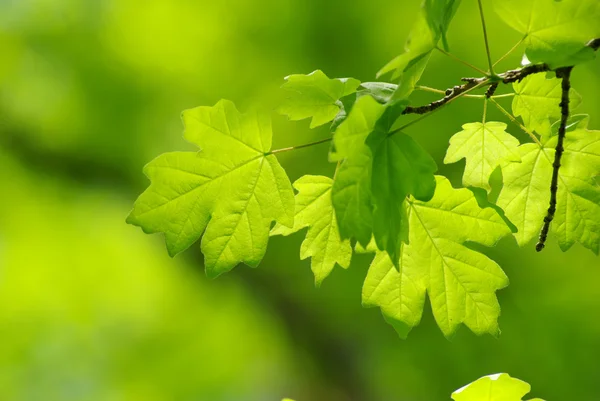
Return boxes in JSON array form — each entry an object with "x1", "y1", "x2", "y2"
[{"x1": 444, "y1": 121, "x2": 521, "y2": 192}]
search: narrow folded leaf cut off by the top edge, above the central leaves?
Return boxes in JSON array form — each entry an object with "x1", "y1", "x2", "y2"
[{"x1": 377, "y1": 0, "x2": 460, "y2": 99}]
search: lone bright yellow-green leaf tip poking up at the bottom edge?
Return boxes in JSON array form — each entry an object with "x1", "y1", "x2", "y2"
[{"x1": 452, "y1": 373, "x2": 543, "y2": 401}]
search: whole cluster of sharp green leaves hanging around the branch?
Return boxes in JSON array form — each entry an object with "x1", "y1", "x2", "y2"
[{"x1": 128, "y1": 0, "x2": 600, "y2": 340}]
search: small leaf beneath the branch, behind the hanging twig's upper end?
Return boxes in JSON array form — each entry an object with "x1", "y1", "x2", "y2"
[{"x1": 512, "y1": 74, "x2": 581, "y2": 136}]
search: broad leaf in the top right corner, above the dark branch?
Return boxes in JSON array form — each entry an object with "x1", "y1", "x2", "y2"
[{"x1": 494, "y1": 0, "x2": 600, "y2": 68}]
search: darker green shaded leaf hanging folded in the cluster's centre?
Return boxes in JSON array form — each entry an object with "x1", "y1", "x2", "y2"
[{"x1": 330, "y1": 96, "x2": 437, "y2": 260}]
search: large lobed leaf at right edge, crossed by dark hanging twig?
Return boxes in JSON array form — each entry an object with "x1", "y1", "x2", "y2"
[{"x1": 497, "y1": 120, "x2": 600, "y2": 254}]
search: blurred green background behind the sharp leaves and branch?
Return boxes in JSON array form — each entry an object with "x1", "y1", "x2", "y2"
[{"x1": 0, "y1": 0, "x2": 600, "y2": 401}]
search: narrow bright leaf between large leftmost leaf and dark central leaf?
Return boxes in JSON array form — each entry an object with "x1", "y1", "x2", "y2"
[{"x1": 271, "y1": 175, "x2": 352, "y2": 286}]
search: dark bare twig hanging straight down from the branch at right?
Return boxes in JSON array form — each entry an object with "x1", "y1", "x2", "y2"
[{"x1": 535, "y1": 67, "x2": 573, "y2": 252}]
